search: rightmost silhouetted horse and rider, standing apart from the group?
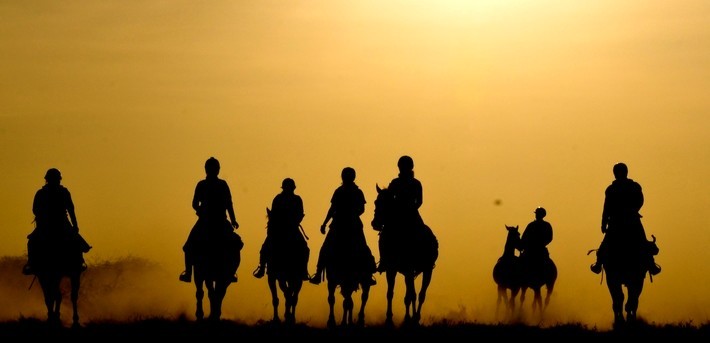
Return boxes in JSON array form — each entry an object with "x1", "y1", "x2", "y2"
[{"x1": 588, "y1": 163, "x2": 661, "y2": 327}]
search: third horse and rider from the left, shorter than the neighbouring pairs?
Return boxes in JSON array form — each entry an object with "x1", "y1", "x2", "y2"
[{"x1": 254, "y1": 178, "x2": 310, "y2": 325}]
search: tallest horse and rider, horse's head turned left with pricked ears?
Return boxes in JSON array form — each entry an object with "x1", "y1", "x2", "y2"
[{"x1": 371, "y1": 155, "x2": 439, "y2": 326}]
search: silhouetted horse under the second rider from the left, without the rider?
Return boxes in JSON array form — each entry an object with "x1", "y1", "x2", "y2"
[{"x1": 194, "y1": 228, "x2": 244, "y2": 321}]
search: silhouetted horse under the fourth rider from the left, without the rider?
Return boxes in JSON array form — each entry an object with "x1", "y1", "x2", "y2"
[{"x1": 324, "y1": 232, "x2": 374, "y2": 328}]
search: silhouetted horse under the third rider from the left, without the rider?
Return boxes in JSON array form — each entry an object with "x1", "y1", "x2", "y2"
[{"x1": 266, "y1": 208, "x2": 310, "y2": 324}]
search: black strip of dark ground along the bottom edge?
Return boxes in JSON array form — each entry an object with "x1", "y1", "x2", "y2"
[{"x1": 0, "y1": 318, "x2": 710, "y2": 343}]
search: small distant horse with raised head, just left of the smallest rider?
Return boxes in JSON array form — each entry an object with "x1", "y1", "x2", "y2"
[{"x1": 493, "y1": 225, "x2": 522, "y2": 317}]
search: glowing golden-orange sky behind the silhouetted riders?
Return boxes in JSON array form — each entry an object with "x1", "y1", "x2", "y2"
[{"x1": 0, "y1": 0, "x2": 710, "y2": 327}]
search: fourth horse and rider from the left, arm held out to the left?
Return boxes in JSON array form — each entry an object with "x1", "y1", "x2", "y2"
[{"x1": 310, "y1": 167, "x2": 377, "y2": 328}]
